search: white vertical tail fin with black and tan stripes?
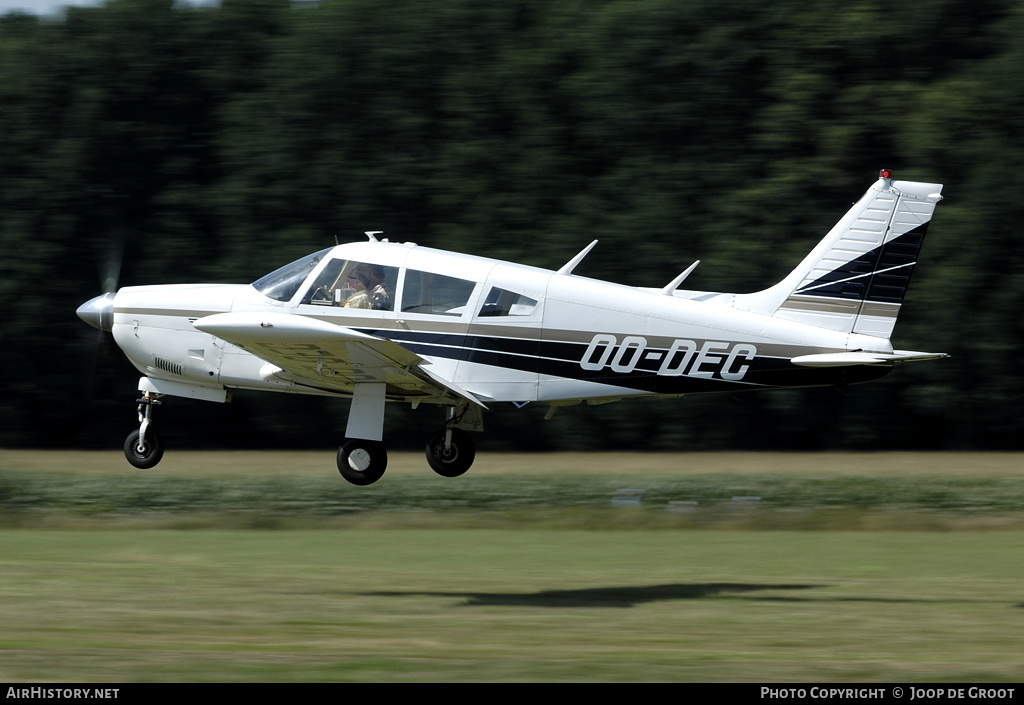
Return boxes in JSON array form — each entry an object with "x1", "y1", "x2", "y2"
[{"x1": 749, "y1": 169, "x2": 942, "y2": 338}]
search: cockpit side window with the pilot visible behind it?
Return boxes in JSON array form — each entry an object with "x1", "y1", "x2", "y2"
[{"x1": 302, "y1": 259, "x2": 398, "y2": 310}]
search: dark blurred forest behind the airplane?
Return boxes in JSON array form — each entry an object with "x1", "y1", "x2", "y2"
[{"x1": 0, "y1": 0, "x2": 1024, "y2": 450}]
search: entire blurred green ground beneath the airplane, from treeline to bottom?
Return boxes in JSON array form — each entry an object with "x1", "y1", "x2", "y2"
[{"x1": 0, "y1": 451, "x2": 1024, "y2": 682}]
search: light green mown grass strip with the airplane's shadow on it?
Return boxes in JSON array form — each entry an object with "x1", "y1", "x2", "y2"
[{"x1": 0, "y1": 528, "x2": 1024, "y2": 683}]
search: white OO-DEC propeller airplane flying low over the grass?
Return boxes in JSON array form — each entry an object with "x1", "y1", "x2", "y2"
[{"x1": 78, "y1": 169, "x2": 947, "y2": 485}]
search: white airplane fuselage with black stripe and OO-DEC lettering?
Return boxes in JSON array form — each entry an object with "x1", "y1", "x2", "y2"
[{"x1": 113, "y1": 237, "x2": 892, "y2": 404}]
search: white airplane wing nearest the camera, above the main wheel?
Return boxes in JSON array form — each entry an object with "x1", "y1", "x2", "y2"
[{"x1": 193, "y1": 312, "x2": 483, "y2": 407}]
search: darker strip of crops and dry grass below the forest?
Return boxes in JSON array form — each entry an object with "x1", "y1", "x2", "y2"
[{"x1": 0, "y1": 451, "x2": 1024, "y2": 530}]
